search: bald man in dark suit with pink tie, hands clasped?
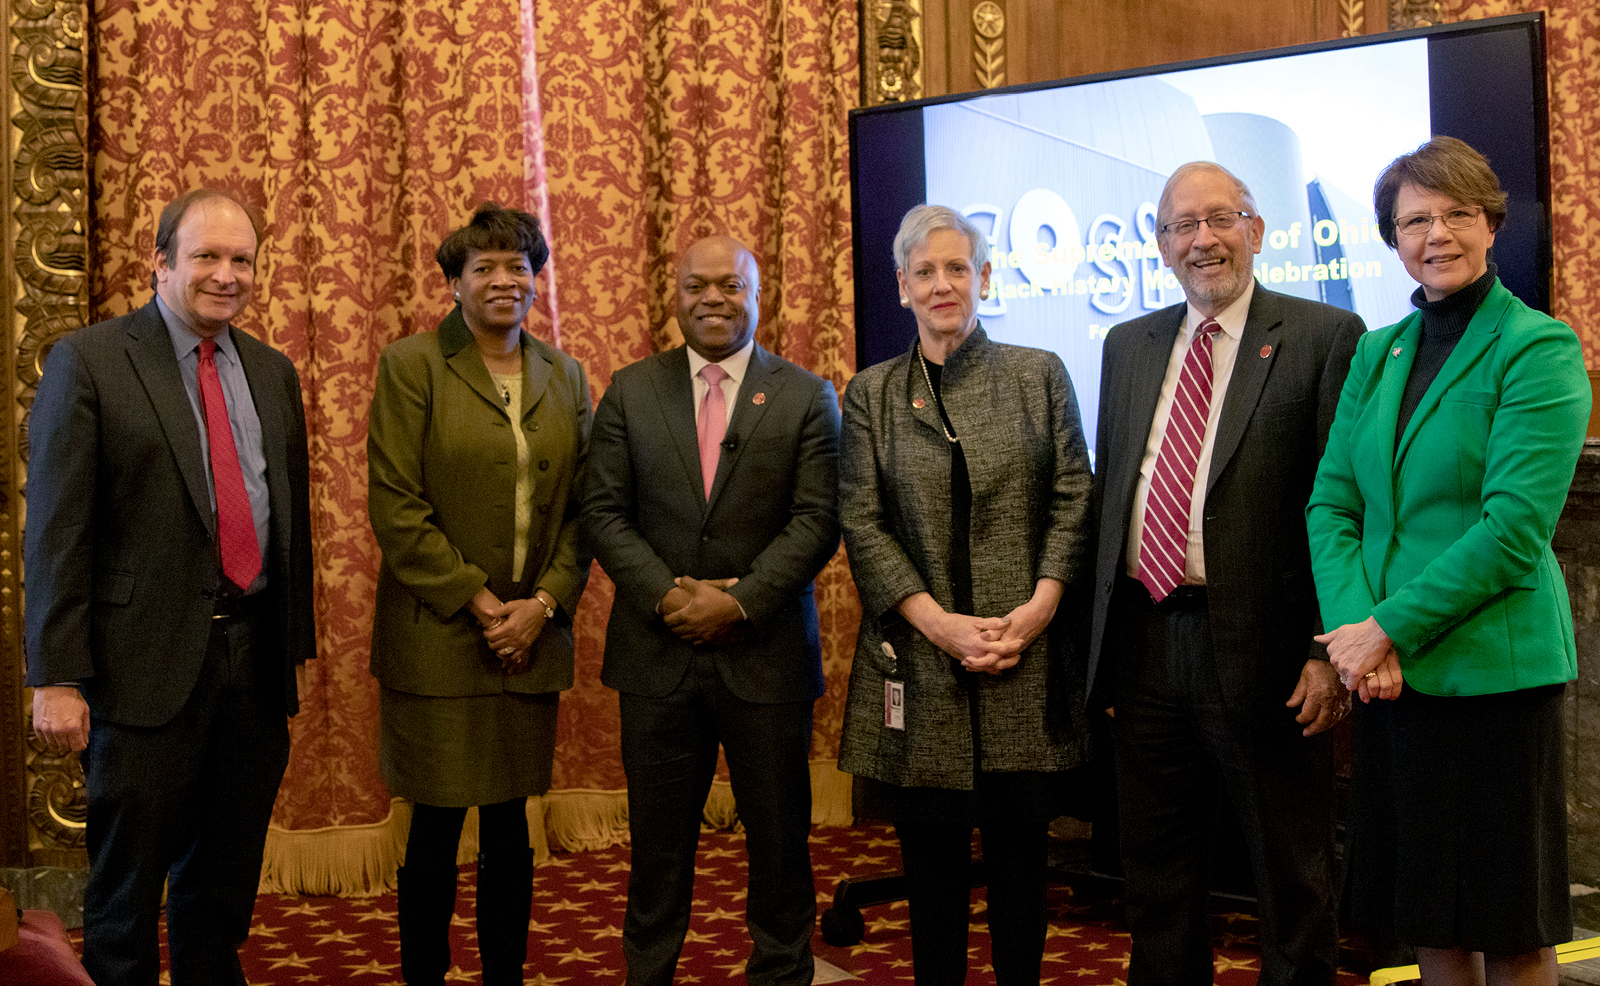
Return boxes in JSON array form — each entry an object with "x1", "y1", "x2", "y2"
[{"x1": 582, "y1": 237, "x2": 838, "y2": 986}]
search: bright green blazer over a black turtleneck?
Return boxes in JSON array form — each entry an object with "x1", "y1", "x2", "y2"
[{"x1": 1306, "y1": 282, "x2": 1590, "y2": 695}]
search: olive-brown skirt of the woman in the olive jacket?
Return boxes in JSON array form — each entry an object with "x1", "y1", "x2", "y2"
[{"x1": 378, "y1": 687, "x2": 560, "y2": 808}]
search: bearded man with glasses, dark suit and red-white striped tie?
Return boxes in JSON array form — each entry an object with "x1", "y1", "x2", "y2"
[{"x1": 1090, "y1": 162, "x2": 1365, "y2": 986}]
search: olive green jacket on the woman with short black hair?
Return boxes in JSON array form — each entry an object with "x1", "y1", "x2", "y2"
[{"x1": 366, "y1": 307, "x2": 590, "y2": 696}]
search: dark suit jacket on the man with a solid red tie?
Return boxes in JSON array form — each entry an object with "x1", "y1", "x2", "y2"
[{"x1": 24, "y1": 298, "x2": 315, "y2": 727}]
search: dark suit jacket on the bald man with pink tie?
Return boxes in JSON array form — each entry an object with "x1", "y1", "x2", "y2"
[{"x1": 581, "y1": 346, "x2": 838, "y2": 703}]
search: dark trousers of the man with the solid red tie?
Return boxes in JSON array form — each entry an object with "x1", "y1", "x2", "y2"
[{"x1": 83, "y1": 615, "x2": 290, "y2": 986}]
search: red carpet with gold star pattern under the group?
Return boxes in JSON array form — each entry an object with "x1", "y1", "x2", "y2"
[{"x1": 62, "y1": 824, "x2": 1362, "y2": 986}]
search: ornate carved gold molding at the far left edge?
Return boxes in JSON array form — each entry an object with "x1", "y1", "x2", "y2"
[{"x1": 0, "y1": 0, "x2": 90, "y2": 866}]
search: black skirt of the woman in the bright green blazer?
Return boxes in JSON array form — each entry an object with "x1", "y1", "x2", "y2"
[{"x1": 1346, "y1": 685, "x2": 1573, "y2": 954}]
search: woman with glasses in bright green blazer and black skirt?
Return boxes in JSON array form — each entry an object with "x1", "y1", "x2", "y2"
[{"x1": 1307, "y1": 138, "x2": 1590, "y2": 986}]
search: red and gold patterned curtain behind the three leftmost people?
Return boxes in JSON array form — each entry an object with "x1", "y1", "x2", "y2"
[{"x1": 90, "y1": 0, "x2": 858, "y2": 892}]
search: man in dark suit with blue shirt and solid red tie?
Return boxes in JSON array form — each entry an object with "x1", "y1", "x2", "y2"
[{"x1": 24, "y1": 189, "x2": 314, "y2": 986}]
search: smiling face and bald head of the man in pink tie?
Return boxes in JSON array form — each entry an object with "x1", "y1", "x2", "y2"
[{"x1": 678, "y1": 237, "x2": 762, "y2": 363}]
